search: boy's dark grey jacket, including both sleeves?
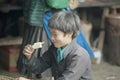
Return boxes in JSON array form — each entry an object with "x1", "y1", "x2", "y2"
[{"x1": 28, "y1": 39, "x2": 92, "y2": 80}]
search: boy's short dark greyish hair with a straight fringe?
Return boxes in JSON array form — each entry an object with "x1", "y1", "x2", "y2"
[{"x1": 48, "y1": 11, "x2": 80, "y2": 38}]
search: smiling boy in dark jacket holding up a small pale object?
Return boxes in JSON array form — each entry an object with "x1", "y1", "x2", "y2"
[{"x1": 17, "y1": 11, "x2": 92, "y2": 80}]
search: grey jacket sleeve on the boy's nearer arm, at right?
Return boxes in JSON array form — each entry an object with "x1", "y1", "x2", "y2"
[{"x1": 57, "y1": 51, "x2": 91, "y2": 80}]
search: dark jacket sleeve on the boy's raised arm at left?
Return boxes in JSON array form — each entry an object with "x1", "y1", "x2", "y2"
[{"x1": 27, "y1": 47, "x2": 51, "y2": 74}]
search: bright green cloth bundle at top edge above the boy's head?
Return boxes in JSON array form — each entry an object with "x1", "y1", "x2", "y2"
[{"x1": 46, "y1": 0, "x2": 69, "y2": 9}]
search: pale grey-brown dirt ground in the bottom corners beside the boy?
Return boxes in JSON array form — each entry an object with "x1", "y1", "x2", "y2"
[{"x1": 0, "y1": 62, "x2": 120, "y2": 80}]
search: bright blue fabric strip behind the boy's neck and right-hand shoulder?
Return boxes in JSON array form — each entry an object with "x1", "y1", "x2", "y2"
[{"x1": 77, "y1": 32, "x2": 94, "y2": 58}]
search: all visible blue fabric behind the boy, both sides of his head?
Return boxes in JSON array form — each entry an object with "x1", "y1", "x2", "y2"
[{"x1": 44, "y1": 8, "x2": 94, "y2": 58}]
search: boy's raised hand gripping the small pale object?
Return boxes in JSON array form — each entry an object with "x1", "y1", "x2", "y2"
[{"x1": 23, "y1": 44, "x2": 34, "y2": 59}]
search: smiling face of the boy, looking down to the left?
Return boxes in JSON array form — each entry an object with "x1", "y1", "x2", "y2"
[{"x1": 50, "y1": 29, "x2": 72, "y2": 48}]
